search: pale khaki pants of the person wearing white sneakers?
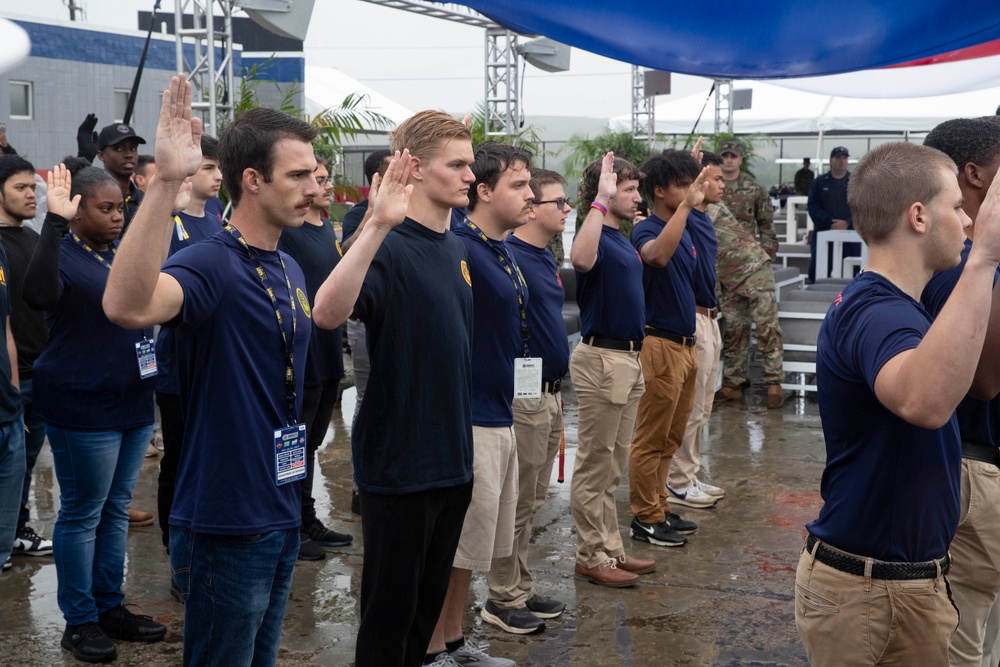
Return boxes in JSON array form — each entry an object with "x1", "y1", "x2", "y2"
[{"x1": 667, "y1": 313, "x2": 722, "y2": 489}]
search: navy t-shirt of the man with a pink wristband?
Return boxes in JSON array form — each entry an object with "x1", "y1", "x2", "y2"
[{"x1": 576, "y1": 225, "x2": 646, "y2": 340}]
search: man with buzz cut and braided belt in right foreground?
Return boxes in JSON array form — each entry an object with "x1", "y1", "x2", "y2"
[{"x1": 795, "y1": 143, "x2": 1000, "y2": 667}]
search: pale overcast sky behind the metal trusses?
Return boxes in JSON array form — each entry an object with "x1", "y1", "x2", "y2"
[{"x1": 21, "y1": 0, "x2": 711, "y2": 118}]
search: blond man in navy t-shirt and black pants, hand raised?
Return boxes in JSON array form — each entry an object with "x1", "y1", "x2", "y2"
[{"x1": 313, "y1": 111, "x2": 476, "y2": 666}]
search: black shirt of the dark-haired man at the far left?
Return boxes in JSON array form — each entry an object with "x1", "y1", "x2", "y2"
[{"x1": 0, "y1": 227, "x2": 49, "y2": 380}]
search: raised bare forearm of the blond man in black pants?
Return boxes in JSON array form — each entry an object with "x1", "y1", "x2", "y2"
[{"x1": 313, "y1": 225, "x2": 389, "y2": 329}]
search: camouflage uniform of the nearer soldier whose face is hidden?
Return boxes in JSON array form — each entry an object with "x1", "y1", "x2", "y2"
[{"x1": 706, "y1": 204, "x2": 785, "y2": 387}]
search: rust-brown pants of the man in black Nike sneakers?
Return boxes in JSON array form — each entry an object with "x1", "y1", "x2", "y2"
[{"x1": 629, "y1": 336, "x2": 698, "y2": 523}]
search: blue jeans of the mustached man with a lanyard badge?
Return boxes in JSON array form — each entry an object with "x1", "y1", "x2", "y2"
[{"x1": 170, "y1": 526, "x2": 299, "y2": 667}]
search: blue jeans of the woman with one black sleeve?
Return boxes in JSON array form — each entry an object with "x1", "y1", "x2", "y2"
[{"x1": 46, "y1": 424, "x2": 153, "y2": 625}]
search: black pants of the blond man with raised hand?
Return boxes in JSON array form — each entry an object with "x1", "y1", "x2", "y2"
[{"x1": 354, "y1": 482, "x2": 472, "y2": 667}]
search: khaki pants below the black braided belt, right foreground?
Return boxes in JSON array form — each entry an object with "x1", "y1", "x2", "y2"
[{"x1": 795, "y1": 541, "x2": 958, "y2": 667}]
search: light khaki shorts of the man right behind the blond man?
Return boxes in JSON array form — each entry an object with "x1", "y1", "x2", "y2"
[{"x1": 454, "y1": 425, "x2": 517, "y2": 572}]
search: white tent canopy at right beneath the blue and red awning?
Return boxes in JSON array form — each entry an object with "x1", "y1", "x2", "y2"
[{"x1": 609, "y1": 81, "x2": 1000, "y2": 134}]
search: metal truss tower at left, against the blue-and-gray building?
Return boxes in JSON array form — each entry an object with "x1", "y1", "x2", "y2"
[{"x1": 174, "y1": 0, "x2": 236, "y2": 135}]
